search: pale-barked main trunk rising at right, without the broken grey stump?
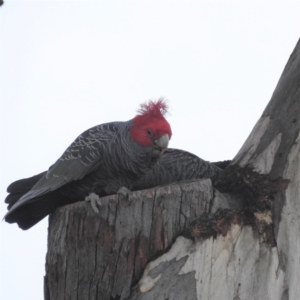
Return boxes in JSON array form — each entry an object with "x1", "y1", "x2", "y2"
[{"x1": 129, "y1": 41, "x2": 300, "y2": 300}]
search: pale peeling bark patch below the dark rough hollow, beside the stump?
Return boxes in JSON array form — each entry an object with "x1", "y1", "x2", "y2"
[{"x1": 129, "y1": 232, "x2": 282, "y2": 300}]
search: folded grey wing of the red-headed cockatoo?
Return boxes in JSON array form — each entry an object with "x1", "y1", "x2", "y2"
[{"x1": 7, "y1": 122, "x2": 120, "y2": 215}]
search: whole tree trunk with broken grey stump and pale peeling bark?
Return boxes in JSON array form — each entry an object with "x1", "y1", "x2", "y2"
[{"x1": 45, "y1": 41, "x2": 300, "y2": 300}]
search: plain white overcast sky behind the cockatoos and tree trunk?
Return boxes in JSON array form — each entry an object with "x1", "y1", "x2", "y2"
[{"x1": 0, "y1": 0, "x2": 300, "y2": 300}]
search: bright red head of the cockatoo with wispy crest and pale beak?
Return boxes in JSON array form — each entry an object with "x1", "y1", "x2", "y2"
[{"x1": 130, "y1": 99, "x2": 172, "y2": 157}]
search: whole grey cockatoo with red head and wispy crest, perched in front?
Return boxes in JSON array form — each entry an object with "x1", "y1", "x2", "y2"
[{"x1": 5, "y1": 99, "x2": 172, "y2": 229}]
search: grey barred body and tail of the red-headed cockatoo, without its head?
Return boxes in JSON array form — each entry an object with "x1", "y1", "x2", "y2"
[{"x1": 5, "y1": 120, "x2": 156, "y2": 229}]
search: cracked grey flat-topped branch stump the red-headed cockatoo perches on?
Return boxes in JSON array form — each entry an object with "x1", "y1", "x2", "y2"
[{"x1": 45, "y1": 179, "x2": 226, "y2": 300}]
